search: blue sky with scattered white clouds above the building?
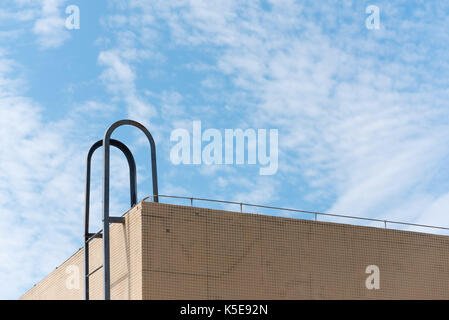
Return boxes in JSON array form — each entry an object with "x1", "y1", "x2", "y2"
[{"x1": 0, "y1": 0, "x2": 449, "y2": 299}]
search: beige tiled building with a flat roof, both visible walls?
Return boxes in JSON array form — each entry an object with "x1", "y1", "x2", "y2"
[{"x1": 21, "y1": 201, "x2": 449, "y2": 299}]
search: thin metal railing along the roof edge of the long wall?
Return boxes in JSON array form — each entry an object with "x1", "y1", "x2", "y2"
[{"x1": 142, "y1": 194, "x2": 449, "y2": 236}]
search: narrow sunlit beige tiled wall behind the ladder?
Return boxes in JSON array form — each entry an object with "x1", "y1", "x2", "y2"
[{"x1": 21, "y1": 204, "x2": 142, "y2": 300}]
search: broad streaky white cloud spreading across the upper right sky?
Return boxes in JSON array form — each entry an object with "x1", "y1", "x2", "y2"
[{"x1": 121, "y1": 0, "x2": 449, "y2": 224}]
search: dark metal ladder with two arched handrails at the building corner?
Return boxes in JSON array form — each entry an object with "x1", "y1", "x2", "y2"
[{"x1": 84, "y1": 120, "x2": 159, "y2": 300}]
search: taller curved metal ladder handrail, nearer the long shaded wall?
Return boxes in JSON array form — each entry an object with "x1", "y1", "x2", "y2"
[{"x1": 103, "y1": 120, "x2": 159, "y2": 300}]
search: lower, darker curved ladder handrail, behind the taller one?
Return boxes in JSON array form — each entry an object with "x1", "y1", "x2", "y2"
[{"x1": 84, "y1": 139, "x2": 137, "y2": 300}]
